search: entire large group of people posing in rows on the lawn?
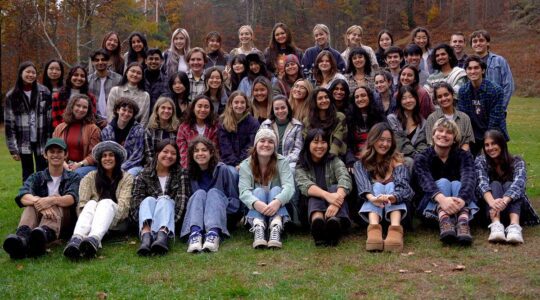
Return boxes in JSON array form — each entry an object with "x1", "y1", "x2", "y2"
[{"x1": 3, "y1": 23, "x2": 540, "y2": 259}]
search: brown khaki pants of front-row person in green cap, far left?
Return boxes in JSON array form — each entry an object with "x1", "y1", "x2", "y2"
[{"x1": 19, "y1": 205, "x2": 71, "y2": 238}]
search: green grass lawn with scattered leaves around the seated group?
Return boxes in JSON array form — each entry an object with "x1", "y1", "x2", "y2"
[{"x1": 0, "y1": 98, "x2": 540, "y2": 299}]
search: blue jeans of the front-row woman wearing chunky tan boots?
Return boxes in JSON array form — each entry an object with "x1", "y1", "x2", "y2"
[{"x1": 358, "y1": 182, "x2": 407, "y2": 223}]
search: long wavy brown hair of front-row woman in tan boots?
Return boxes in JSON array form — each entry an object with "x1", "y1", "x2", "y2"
[{"x1": 361, "y1": 122, "x2": 403, "y2": 179}]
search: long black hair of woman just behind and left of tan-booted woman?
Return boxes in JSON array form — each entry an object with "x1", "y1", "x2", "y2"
[{"x1": 347, "y1": 86, "x2": 386, "y2": 130}]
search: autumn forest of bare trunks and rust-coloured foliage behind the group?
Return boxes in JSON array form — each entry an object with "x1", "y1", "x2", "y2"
[{"x1": 0, "y1": 0, "x2": 540, "y2": 102}]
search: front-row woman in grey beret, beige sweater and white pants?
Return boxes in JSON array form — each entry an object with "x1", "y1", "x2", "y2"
[{"x1": 64, "y1": 141, "x2": 133, "y2": 259}]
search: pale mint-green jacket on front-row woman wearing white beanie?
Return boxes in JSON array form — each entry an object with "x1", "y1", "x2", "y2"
[{"x1": 238, "y1": 154, "x2": 294, "y2": 209}]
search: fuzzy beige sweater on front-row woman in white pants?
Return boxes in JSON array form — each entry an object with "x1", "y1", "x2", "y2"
[{"x1": 77, "y1": 171, "x2": 133, "y2": 228}]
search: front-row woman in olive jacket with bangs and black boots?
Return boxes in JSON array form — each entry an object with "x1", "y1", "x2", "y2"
[{"x1": 296, "y1": 128, "x2": 352, "y2": 246}]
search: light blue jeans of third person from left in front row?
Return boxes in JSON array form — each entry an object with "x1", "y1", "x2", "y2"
[{"x1": 139, "y1": 195, "x2": 175, "y2": 236}]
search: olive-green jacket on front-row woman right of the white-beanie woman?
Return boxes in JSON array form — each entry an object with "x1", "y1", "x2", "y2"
[{"x1": 295, "y1": 156, "x2": 352, "y2": 197}]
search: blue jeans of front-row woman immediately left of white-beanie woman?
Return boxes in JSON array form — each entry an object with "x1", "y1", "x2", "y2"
[{"x1": 180, "y1": 188, "x2": 229, "y2": 237}]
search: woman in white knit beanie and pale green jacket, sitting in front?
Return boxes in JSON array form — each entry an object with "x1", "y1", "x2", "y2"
[{"x1": 238, "y1": 128, "x2": 294, "y2": 249}]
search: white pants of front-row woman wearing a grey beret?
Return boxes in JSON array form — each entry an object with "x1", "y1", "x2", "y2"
[{"x1": 73, "y1": 199, "x2": 118, "y2": 246}]
